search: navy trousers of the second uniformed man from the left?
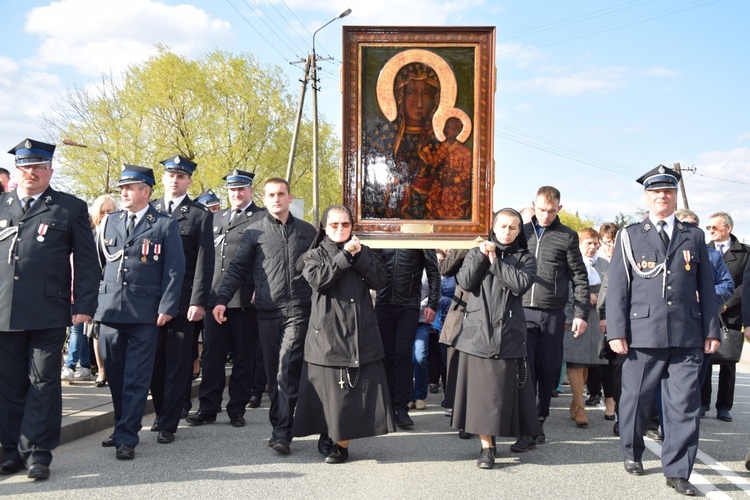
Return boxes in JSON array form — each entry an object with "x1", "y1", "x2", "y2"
[{"x1": 99, "y1": 322, "x2": 159, "y2": 447}]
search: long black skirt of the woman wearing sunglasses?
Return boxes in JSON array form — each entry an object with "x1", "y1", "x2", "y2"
[{"x1": 292, "y1": 361, "x2": 396, "y2": 441}]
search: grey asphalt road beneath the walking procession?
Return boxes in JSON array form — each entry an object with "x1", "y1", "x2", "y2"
[{"x1": 0, "y1": 365, "x2": 750, "y2": 500}]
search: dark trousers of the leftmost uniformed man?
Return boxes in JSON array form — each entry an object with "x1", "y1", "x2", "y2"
[{"x1": 0, "y1": 327, "x2": 65, "y2": 467}]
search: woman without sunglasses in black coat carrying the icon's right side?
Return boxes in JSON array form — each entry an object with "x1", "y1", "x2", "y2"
[{"x1": 452, "y1": 208, "x2": 540, "y2": 469}]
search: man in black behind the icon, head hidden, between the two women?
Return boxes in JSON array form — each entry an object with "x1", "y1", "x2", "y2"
[{"x1": 375, "y1": 249, "x2": 440, "y2": 427}]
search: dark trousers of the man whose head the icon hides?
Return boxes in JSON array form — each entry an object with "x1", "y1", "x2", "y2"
[{"x1": 375, "y1": 305, "x2": 419, "y2": 411}]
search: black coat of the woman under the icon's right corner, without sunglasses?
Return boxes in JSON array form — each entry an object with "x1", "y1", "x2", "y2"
[{"x1": 455, "y1": 244, "x2": 537, "y2": 359}]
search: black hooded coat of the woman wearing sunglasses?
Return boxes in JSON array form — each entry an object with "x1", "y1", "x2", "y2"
[{"x1": 302, "y1": 240, "x2": 387, "y2": 368}]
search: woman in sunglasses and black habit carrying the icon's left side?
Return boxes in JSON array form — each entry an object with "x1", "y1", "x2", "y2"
[{"x1": 292, "y1": 205, "x2": 396, "y2": 464}]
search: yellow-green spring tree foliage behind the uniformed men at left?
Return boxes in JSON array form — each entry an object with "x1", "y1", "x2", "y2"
[{"x1": 44, "y1": 47, "x2": 341, "y2": 219}]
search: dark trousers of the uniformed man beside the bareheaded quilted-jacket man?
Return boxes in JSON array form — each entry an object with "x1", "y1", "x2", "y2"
[{"x1": 199, "y1": 307, "x2": 258, "y2": 417}]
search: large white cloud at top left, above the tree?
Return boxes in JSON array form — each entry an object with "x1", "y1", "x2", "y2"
[{"x1": 25, "y1": 0, "x2": 231, "y2": 75}]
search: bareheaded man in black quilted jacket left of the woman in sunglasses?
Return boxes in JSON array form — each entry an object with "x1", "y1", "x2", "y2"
[{"x1": 213, "y1": 177, "x2": 317, "y2": 455}]
